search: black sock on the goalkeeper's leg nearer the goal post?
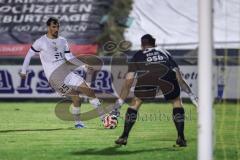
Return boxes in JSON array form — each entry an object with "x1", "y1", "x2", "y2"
[{"x1": 173, "y1": 108, "x2": 185, "y2": 140}]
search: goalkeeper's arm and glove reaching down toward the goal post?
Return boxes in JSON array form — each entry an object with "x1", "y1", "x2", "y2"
[{"x1": 174, "y1": 68, "x2": 198, "y2": 107}]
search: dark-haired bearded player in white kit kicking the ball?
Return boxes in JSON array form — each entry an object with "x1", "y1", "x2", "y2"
[{"x1": 19, "y1": 17, "x2": 104, "y2": 128}]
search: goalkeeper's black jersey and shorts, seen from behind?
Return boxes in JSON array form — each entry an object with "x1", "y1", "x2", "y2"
[{"x1": 129, "y1": 48, "x2": 180, "y2": 100}]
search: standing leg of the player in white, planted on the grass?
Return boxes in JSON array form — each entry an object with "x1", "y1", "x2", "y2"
[{"x1": 71, "y1": 94, "x2": 85, "y2": 128}]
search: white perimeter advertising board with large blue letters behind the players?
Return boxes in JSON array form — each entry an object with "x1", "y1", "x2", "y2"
[{"x1": 0, "y1": 65, "x2": 240, "y2": 99}]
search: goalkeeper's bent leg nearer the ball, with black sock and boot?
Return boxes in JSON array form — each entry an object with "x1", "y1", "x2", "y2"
[{"x1": 115, "y1": 97, "x2": 142, "y2": 145}]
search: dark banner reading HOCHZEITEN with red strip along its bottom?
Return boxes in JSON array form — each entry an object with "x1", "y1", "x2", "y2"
[{"x1": 0, "y1": 0, "x2": 111, "y2": 56}]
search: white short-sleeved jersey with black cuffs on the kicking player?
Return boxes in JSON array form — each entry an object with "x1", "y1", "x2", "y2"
[{"x1": 31, "y1": 35, "x2": 70, "y2": 80}]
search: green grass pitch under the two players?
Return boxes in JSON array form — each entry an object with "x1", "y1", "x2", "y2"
[{"x1": 0, "y1": 102, "x2": 240, "y2": 160}]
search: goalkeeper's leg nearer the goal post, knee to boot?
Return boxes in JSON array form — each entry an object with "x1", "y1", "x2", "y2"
[{"x1": 170, "y1": 96, "x2": 187, "y2": 147}]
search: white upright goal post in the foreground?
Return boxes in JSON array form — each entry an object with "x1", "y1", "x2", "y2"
[{"x1": 198, "y1": 0, "x2": 213, "y2": 160}]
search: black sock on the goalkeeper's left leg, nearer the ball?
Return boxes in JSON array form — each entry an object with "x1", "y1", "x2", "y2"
[{"x1": 121, "y1": 108, "x2": 137, "y2": 138}]
